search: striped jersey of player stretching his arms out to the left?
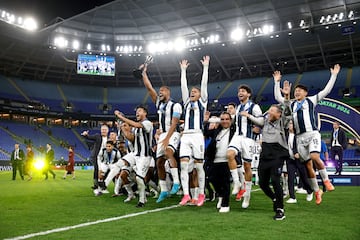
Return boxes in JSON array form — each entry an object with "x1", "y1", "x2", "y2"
[{"x1": 134, "y1": 119, "x2": 153, "y2": 157}]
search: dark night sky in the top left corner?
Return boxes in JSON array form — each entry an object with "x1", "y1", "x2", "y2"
[{"x1": 0, "y1": 0, "x2": 112, "y2": 27}]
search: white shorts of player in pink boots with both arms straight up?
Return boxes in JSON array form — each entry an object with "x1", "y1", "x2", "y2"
[{"x1": 179, "y1": 133, "x2": 205, "y2": 160}]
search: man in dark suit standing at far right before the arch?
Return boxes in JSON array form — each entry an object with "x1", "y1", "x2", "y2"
[{"x1": 330, "y1": 121, "x2": 347, "y2": 175}]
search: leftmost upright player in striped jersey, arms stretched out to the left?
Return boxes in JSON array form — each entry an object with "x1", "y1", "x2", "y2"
[{"x1": 114, "y1": 106, "x2": 153, "y2": 208}]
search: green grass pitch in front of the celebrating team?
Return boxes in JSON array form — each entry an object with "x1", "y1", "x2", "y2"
[{"x1": 0, "y1": 171, "x2": 360, "y2": 240}]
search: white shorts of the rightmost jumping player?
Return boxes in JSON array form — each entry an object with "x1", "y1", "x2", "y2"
[{"x1": 296, "y1": 131, "x2": 321, "y2": 162}]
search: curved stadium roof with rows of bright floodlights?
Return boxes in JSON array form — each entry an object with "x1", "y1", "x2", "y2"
[{"x1": 0, "y1": 0, "x2": 360, "y2": 86}]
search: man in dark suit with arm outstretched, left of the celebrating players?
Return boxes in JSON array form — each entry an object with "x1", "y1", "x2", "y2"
[{"x1": 81, "y1": 124, "x2": 109, "y2": 189}]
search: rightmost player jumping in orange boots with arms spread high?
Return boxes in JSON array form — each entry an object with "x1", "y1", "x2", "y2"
[{"x1": 273, "y1": 64, "x2": 340, "y2": 204}]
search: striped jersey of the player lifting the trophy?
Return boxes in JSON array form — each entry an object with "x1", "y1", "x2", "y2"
[{"x1": 155, "y1": 97, "x2": 182, "y2": 133}]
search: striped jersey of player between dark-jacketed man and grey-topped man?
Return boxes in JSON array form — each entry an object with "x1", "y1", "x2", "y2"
[{"x1": 235, "y1": 101, "x2": 262, "y2": 139}]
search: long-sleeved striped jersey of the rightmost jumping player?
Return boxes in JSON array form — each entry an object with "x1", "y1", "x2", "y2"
[{"x1": 274, "y1": 74, "x2": 337, "y2": 134}]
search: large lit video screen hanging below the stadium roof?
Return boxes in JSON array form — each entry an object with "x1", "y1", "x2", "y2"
[{"x1": 77, "y1": 54, "x2": 115, "y2": 76}]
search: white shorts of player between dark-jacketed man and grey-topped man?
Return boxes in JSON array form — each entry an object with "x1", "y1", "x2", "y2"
[{"x1": 228, "y1": 135, "x2": 259, "y2": 163}]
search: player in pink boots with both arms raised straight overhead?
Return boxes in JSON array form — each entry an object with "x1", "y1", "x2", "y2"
[{"x1": 180, "y1": 56, "x2": 210, "y2": 206}]
